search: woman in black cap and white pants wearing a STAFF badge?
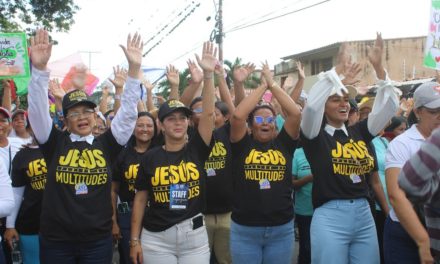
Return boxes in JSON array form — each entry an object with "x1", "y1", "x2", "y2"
[{"x1": 130, "y1": 42, "x2": 217, "y2": 264}]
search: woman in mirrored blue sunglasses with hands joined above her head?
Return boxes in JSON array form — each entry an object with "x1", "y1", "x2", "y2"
[{"x1": 230, "y1": 63, "x2": 301, "y2": 263}]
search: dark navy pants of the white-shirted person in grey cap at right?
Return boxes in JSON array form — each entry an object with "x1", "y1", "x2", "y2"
[{"x1": 383, "y1": 216, "x2": 420, "y2": 264}]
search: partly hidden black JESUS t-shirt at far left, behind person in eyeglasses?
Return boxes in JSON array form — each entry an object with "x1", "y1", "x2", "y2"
[{"x1": 11, "y1": 147, "x2": 47, "y2": 235}]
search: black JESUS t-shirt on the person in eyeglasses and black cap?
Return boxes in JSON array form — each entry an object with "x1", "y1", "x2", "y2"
[{"x1": 40, "y1": 125, "x2": 122, "y2": 242}]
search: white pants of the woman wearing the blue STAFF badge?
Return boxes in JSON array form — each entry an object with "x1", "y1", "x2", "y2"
[{"x1": 141, "y1": 214, "x2": 210, "y2": 264}]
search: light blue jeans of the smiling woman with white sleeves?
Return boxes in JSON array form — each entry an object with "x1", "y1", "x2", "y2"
[{"x1": 310, "y1": 198, "x2": 380, "y2": 264}]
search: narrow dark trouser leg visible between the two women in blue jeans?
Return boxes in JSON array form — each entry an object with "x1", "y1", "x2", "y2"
[{"x1": 295, "y1": 214, "x2": 312, "y2": 264}]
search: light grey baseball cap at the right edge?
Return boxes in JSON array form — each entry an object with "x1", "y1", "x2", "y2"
[{"x1": 414, "y1": 82, "x2": 440, "y2": 109}]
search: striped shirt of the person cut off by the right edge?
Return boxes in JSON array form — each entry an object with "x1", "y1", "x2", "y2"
[{"x1": 399, "y1": 128, "x2": 440, "y2": 257}]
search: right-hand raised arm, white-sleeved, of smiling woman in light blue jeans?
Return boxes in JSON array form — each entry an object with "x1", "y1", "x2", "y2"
[{"x1": 368, "y1": 33, "x2": 399, "y2": 135}]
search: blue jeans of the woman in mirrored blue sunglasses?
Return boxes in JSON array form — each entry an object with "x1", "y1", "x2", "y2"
[{"x1": 231, "y1": 220, "x2": 294, "y2": 264}]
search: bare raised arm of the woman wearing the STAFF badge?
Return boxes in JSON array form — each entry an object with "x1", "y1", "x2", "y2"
[{"x1": 196, "y1": 42, "x2": 217, "y2": 145}]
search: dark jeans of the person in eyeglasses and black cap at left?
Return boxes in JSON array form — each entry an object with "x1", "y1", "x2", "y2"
[{"x1": 40, "y1": 235, "x2": 113, "y2": 264}]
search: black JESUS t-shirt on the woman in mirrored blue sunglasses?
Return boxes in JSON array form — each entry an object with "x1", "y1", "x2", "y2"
[{"x1": 231, "y1": 128, "x2": 298, "y2": 226}]
